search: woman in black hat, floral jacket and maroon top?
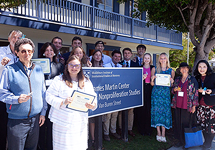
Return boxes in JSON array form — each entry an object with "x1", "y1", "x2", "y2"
[{"x1": 172, "y1": 62, "x2": 198, "y2": 147}]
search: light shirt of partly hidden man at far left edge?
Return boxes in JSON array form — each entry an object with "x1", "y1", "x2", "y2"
[{"x1": 0, "y1": 45, "x2": 19, "y2": 76}]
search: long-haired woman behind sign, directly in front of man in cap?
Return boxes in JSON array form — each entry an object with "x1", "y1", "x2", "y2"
[{"x1": 89, "y1": 50, "x2": 103, "y2": 146}]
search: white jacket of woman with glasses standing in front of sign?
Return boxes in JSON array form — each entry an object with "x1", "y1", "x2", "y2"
[{"x1": 46, "y1": 75, "x2": 97, "y2": 127}]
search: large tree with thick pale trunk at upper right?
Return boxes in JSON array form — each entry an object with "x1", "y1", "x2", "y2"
[{"x1": 120, "y1": 0, "x2": 215, "y2": 67}]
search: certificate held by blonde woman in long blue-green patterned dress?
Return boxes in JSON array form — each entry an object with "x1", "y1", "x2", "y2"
[{"x1": 155, "y1": 74, "x2": 171, "y2": 86}]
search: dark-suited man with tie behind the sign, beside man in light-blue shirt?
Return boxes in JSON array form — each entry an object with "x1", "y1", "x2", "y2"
[{"x1": 118, "y1": 48, "x2": 139, "y2": 137}]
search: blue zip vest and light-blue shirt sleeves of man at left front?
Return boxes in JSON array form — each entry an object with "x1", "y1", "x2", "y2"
[{"x1": 0, "y1": 61, "x2": 46, "y2": 119}]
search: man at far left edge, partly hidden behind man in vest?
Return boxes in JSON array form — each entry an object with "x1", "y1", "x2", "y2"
[{"x1": 0, "y1": 30, "x2": 22, "y2": 150}]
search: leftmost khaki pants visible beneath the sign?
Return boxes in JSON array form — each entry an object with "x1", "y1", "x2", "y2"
[{"x1": 102, "y1": 112, "x2": 118, "y2": 135}]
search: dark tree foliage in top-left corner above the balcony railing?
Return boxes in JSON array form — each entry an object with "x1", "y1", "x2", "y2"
[{"x1": 0, "y1": 0, "x2": 27, "y2": 9}]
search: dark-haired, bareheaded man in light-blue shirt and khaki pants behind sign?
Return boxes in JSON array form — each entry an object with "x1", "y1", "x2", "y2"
[{"x1": 102, "y1": 50, "x2": 122, "y2": 141}]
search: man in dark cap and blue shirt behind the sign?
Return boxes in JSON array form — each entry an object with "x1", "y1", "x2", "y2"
[{"x1": 90, "y1": 41, "x2": 112, "y2": 65}]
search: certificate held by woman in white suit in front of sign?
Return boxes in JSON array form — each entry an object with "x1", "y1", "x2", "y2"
[{"x1": 66, "y1": 90, "x2": 95, "y2": 112}]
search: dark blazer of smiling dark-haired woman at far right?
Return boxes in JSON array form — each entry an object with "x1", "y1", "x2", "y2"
[{"x1": 195, "y1": 73, "x2": 215, "y2": 106}]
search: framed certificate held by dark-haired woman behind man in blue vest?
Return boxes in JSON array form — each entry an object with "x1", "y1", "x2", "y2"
[{"x1": 31, "y1": 58, "x2": 51, "y2": 75}]
